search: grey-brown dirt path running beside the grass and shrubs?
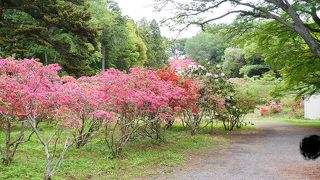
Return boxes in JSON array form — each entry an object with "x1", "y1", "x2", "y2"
[{"x1": 156, "y1": 122, "x2": 320, "y2": 180}]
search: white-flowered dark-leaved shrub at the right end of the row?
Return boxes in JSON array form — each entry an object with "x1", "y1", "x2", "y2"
[{"x1": 172, "y1": 60, "x2": 256, "y2": 132}]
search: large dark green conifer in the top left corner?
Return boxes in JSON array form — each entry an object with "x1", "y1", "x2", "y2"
[{"x1": 0, "y1": 0, "x2": 96, "y2": 76}]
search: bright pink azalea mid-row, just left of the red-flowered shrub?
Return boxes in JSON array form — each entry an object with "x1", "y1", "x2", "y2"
[{"x1": 96, "y1": 68, "x2": 185, "y2": 156}]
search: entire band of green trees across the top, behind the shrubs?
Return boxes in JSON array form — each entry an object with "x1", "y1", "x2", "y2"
[{"x1": 0, "y1": 0, "x2": 320, "y2": 94}]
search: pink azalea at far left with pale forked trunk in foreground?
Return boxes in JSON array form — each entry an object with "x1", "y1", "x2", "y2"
[{"x1": 0, "y1": 59, "x2": 85, "y2": 179}]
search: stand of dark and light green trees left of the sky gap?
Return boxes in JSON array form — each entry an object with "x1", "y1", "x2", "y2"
[{"x1": 0, "y1": 0, "x2": 168, "y2": 76}]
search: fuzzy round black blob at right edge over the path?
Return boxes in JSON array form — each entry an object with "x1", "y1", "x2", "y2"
[{"x1": 300, "y1": 135, "x2": 320, "y2": 160}]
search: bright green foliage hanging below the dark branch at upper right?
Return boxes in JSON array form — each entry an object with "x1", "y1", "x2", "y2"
[{"x1": 234, "y1": 21, "x2": 320, "y2": 95}]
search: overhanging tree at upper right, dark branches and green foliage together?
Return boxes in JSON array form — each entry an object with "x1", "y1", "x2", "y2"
[{"x1": 158, "y1": 0, "x2": 320, "y2": 94}]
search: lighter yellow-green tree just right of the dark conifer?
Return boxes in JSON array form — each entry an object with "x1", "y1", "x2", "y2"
[{"x1": 89, "y1": 0, "x2": 147, "y2": 70}]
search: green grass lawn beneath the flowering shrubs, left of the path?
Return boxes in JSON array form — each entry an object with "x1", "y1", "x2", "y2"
[{"x1": 0, "y1": 121, "x2": 253, "y2": 179}]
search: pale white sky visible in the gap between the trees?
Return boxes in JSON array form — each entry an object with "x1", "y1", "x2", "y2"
[{"x1": 115, "y1": 0, "x2": 234, "y2": 38}]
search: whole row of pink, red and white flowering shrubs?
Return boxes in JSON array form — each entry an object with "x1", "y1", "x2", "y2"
[{"x1": 0, "y1": 59, "x2": 256, "y2": 179}]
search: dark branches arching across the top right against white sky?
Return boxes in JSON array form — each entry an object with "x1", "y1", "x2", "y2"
[{"x1": 157, "y1": 0, "x2": 320, "y2": 58}]
